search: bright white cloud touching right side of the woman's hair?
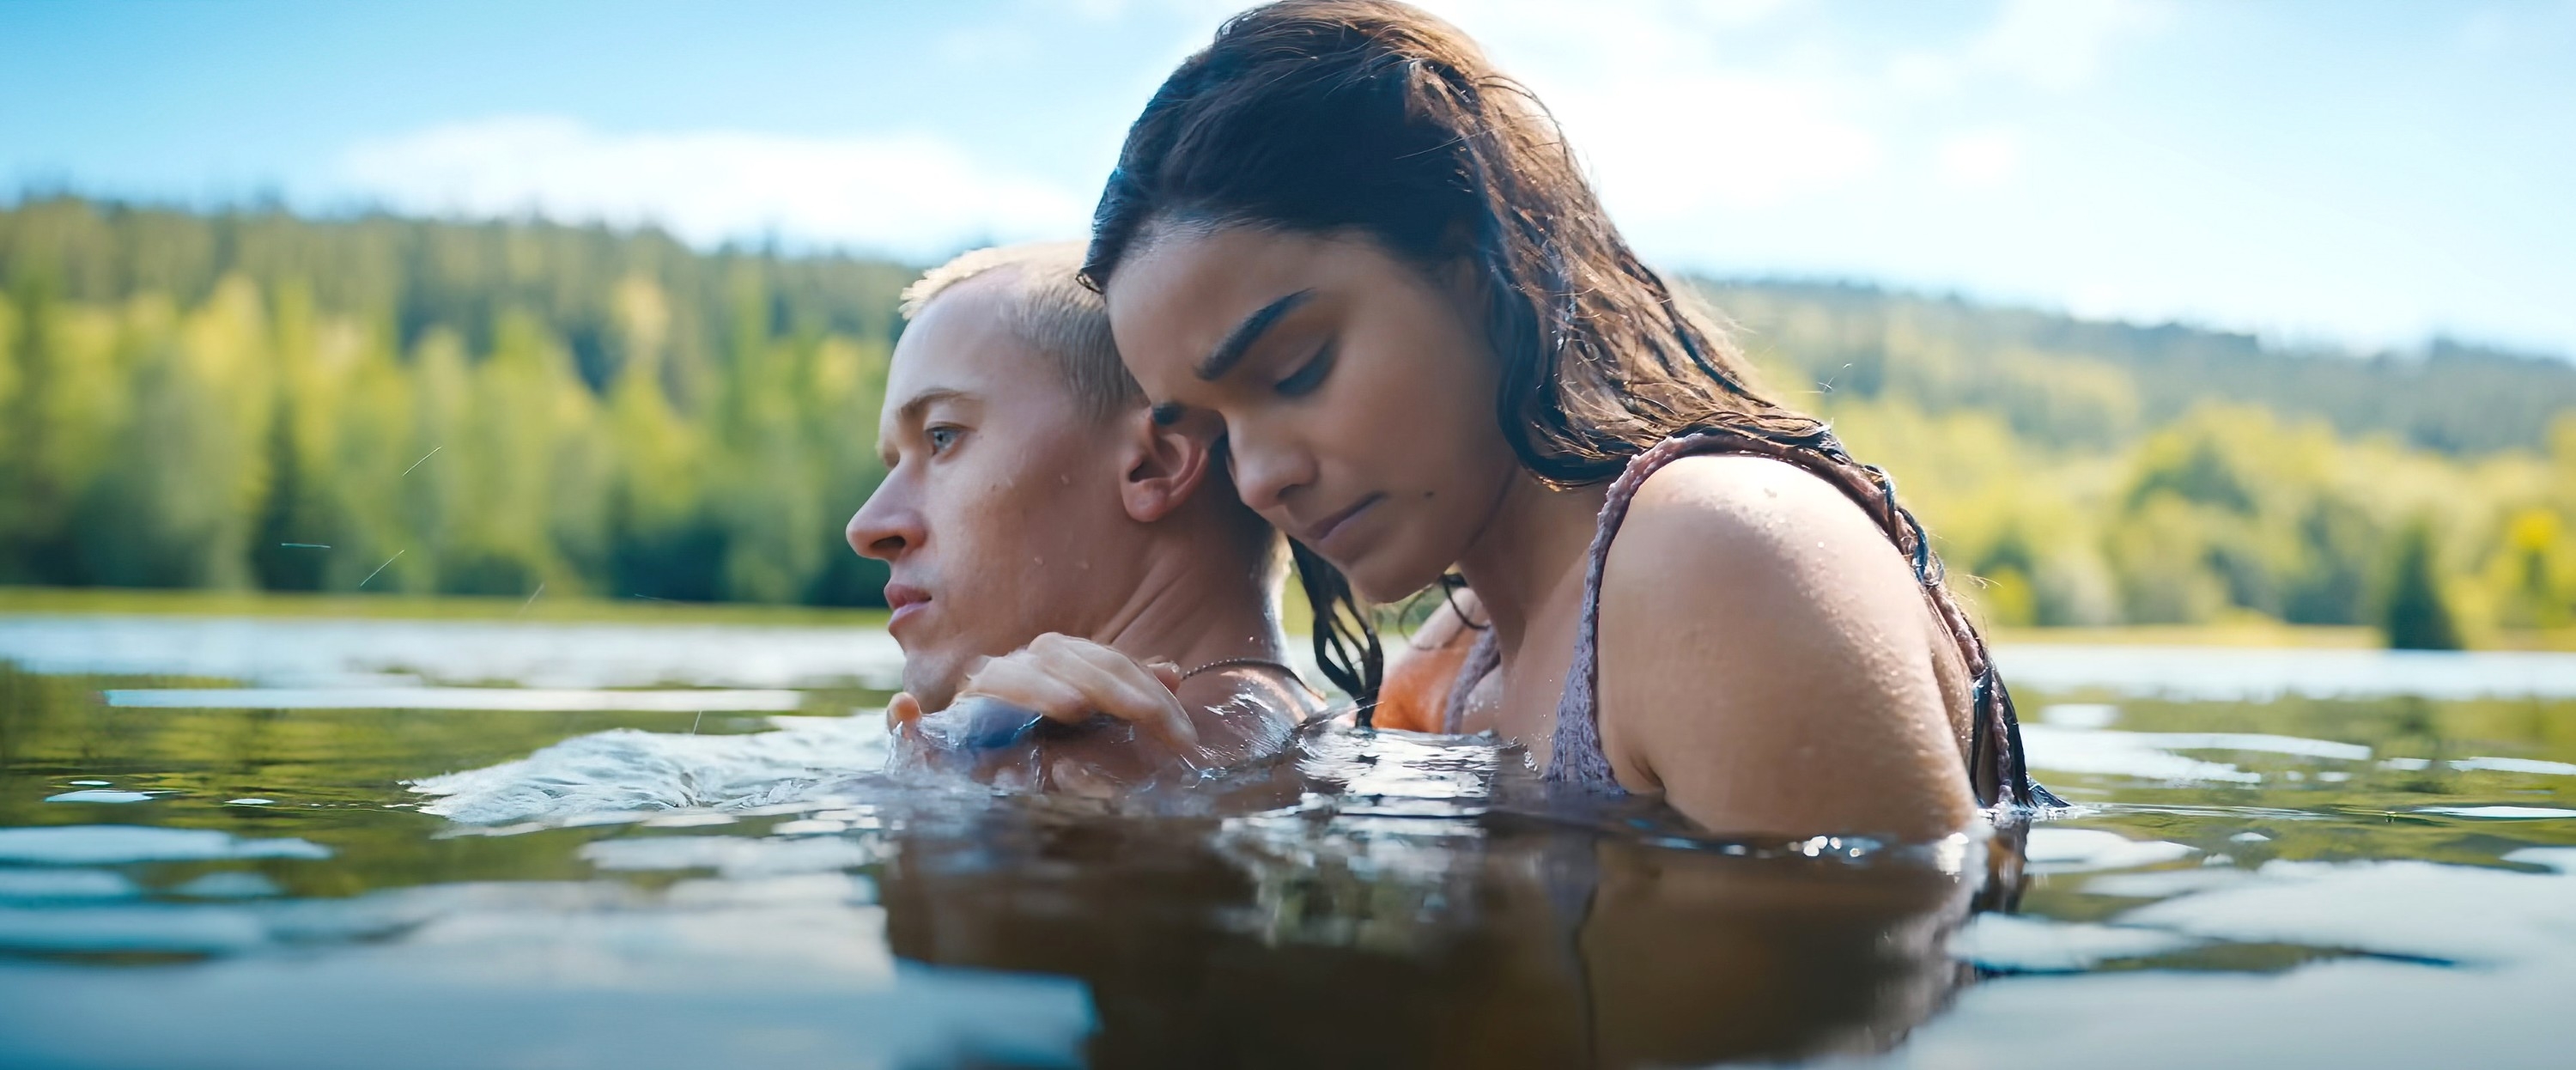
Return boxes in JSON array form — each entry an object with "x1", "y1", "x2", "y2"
[{"x1": 1435, "y1": 0, "x2": 2166, "y2": 222}]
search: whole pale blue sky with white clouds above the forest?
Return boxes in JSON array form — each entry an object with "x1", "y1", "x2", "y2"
[{"x1": 15, "y1": 0, "x2": 2576, "y2": 353}]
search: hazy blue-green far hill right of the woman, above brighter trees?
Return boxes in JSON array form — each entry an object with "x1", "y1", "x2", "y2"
[{"x1": 1700, "y1": 281, "x2": 2576, "y2": 453}]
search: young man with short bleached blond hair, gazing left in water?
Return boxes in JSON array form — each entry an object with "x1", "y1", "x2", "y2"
[{"x1": 848, "y1": 242, "x2": 1321, "y2": 789}]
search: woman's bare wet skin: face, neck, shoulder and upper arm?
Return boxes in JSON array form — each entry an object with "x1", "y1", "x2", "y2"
[{"x1": 1108, "y1": 227, "x2": 1976, "y2": 838}]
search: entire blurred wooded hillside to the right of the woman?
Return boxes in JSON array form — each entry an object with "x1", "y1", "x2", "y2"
[{"x1": 1710, "y1": 286, "x2": 2576, "y2": 645}]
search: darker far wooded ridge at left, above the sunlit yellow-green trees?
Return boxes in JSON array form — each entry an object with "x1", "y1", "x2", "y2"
[{"x1": 0, "y1": 196, "x2": 917, "y2": 399}]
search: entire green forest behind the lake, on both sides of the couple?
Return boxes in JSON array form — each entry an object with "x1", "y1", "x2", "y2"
[{"x1": 0, "y1": 196, "x2": 2576, "y2": 647}]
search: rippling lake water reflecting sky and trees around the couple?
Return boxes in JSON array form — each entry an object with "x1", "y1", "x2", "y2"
[{"x1": 0, "y1": 617, "x2": 2576, "y2": 1070}]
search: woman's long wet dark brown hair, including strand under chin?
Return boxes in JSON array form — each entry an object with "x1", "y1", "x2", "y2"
[{"x1": 1082, "y1": 0, "x2": 1937, "y2": 737}]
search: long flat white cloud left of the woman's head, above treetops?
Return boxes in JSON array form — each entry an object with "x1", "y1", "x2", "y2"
[{"x1": 340, "y1": 116, "x2": 1090, "y2": 255}]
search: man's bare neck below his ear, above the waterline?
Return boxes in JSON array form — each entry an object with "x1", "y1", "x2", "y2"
[{"x1": 1092, "y1": 533, "x2": 1283, "y2": 671}]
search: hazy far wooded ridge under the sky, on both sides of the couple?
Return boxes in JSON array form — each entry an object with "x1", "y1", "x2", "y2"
[{"x1": 0, "y1": 198, "x2": 2576, "y2": 453}]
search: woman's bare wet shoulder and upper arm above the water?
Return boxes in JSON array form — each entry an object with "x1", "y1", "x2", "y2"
[{"x1": 1597, "y1": 456, "x2": 1976, "y2": 841}]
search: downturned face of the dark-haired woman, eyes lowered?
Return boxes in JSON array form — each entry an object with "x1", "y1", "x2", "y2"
[{"x1": 1108, "y1": 227, "x2": 1517, "y2": 601}]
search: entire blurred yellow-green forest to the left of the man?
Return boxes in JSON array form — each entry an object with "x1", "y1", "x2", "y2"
[{"x1": 0, "y1": 198, "x2": 907, "y2": 604}]
